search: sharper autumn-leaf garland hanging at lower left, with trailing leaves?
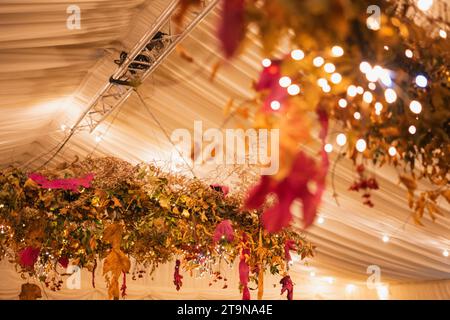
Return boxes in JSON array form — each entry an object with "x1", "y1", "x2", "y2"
[{"x1": 0, "y1": 158, "x2": 314, "y2": 299}]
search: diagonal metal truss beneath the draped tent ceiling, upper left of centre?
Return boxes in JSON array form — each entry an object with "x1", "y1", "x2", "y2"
[{"x1": 68, "y1": 0, "x2": 219, "y2": 135}]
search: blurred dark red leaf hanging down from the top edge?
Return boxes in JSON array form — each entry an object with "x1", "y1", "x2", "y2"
[{"x1": 219, "y1": 0, "x2": 245, "y2": 58}]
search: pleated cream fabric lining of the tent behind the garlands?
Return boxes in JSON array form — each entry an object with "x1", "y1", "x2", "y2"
[{"x1": 0, "y1": 0, "x2": 450, "y2": 299}]
